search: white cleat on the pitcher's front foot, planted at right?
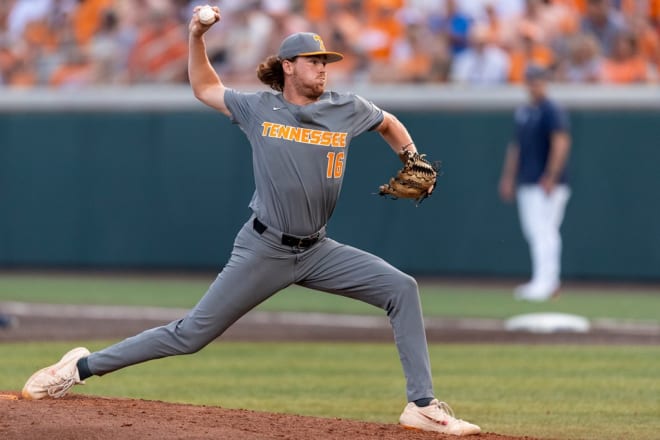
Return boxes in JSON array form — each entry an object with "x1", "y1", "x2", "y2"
[{"x1": 399, "y1": 399, "x2": 481, "y2": 436}]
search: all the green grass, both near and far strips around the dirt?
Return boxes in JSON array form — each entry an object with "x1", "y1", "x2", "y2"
[{"x1": 0, "y1": 273, "x2": 660, "y2": 440}]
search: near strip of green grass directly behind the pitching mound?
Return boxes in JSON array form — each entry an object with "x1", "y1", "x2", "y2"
[{"x1": 0, "y1": 341, "x2": 660, "y2": 440}]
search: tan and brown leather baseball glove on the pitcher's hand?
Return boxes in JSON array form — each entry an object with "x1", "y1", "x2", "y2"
[{"x1": 378, "y1": 150, "x2": 440, "y2": 204}]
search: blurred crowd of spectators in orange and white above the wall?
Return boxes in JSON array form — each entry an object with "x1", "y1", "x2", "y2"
[{"x1": 0, "y1": 0, "x2": 660, "y2": 88}]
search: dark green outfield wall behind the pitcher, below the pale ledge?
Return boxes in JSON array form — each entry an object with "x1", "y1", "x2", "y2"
[{"x1": 0, "y1": 99, "x2": 660, "y2": 280}]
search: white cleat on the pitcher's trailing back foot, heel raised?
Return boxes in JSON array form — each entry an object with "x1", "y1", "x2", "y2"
[{"x1": 21, "y1": 347, "x2": 90, "y2": 400}]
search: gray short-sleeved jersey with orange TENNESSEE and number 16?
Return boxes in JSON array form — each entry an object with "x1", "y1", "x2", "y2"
[{"x1": 225, "y1": 89, "x2": 383, "y2": 236}]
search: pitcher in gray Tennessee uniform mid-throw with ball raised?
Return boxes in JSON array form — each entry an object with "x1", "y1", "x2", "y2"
[{"x1": 22, "y1": 7, "x2": 480, "y2": 435}]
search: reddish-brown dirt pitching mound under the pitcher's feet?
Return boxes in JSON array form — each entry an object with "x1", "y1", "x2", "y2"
[{"x1": 0, "y1": 392, "x2": 533, "y2": 440}]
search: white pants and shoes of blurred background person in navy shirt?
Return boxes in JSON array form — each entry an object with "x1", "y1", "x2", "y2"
[{"x1": 516, "y1": 185, "x2": 571, "y2": 301}]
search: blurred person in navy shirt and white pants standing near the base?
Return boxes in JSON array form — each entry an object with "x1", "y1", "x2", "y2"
[{"x1": 499, "y1": 65, "x2": 571, "y2": 301}]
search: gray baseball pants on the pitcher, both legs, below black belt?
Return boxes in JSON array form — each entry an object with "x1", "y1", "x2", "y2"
[{"x1": 87, "y1": 218, "x2": 434, "y2": 401}]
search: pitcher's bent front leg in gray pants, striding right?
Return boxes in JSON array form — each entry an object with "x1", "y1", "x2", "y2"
[{"x1": 296, "y1": 239, "x2": 434, "y2": 401}]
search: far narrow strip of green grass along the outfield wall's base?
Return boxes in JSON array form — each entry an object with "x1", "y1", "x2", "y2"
[{"x1": 0, "y1": 273, "x2": 660, "y2": 322}]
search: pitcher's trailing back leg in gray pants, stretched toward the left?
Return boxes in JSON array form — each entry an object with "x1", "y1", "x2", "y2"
[{"x1": 87, "y1": 223, "x2": 293, "y2": 375}]
